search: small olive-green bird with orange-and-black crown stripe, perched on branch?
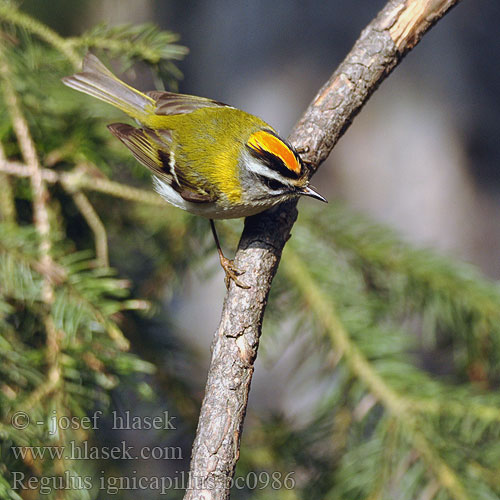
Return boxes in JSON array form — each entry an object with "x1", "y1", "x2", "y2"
[{"x1": 62, "y1": 53, "x2": 326, "y2": 288}]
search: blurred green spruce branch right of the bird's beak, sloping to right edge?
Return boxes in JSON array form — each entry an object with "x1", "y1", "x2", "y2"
[{"x1": 302, "y1": 203, "x2": 500, "y2": 376}]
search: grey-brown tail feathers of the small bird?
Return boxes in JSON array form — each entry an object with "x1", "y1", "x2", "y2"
[{"x1": 62, "y1": 53, "x2": 155, "y2": 121}]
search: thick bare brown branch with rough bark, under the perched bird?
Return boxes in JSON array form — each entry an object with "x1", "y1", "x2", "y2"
[{"x1": 184, "y1": 0, "x2": 458, "y2": 500}]
